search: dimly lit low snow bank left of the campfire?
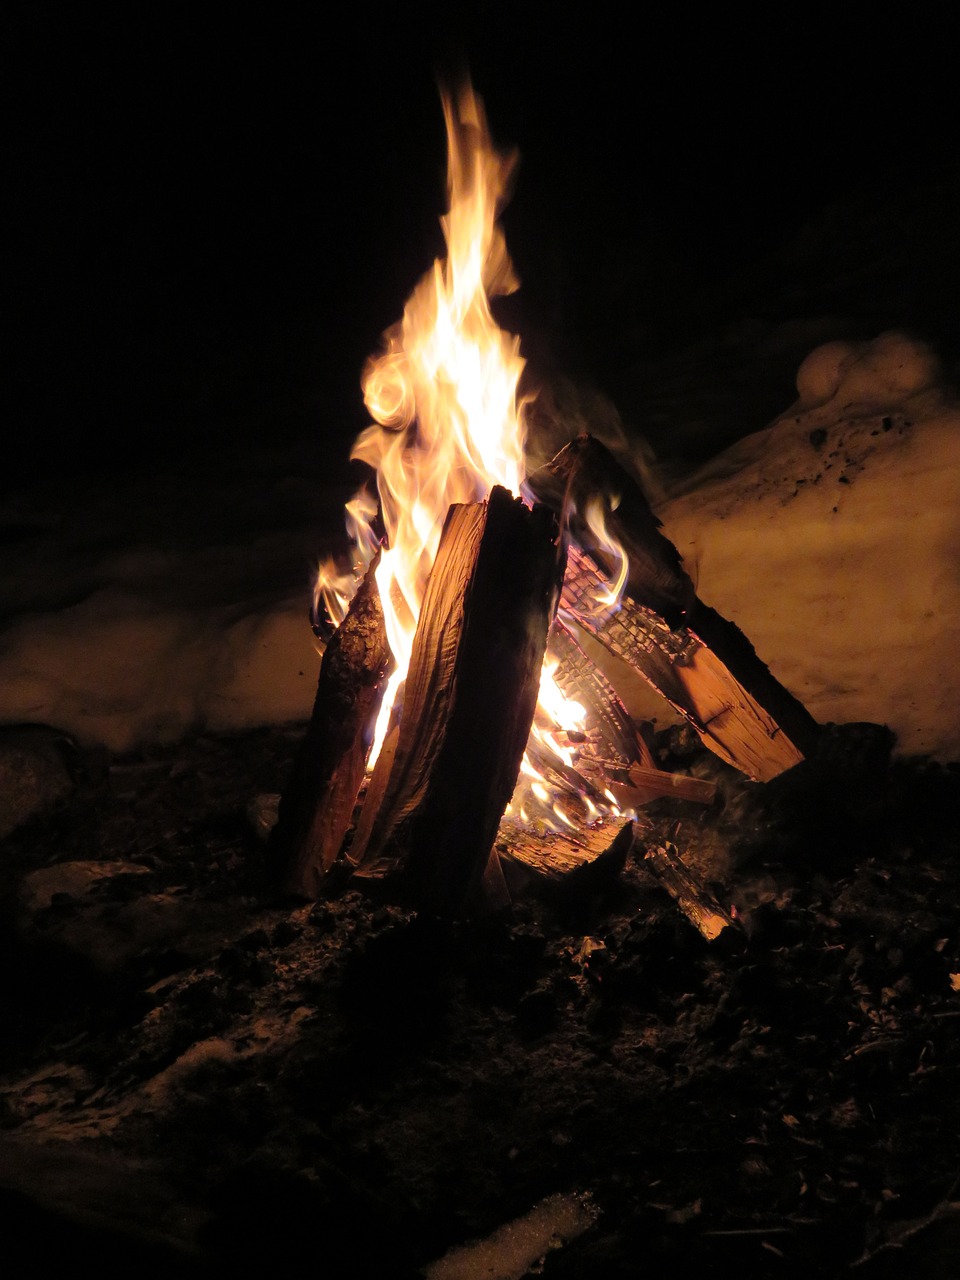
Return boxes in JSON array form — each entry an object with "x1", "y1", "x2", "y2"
[{"x1": 0, "y1": 589, "x2": 320, "y2": 751}]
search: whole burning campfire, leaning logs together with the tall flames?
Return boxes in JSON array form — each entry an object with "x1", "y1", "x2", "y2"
[{"x1": 275, "y1": 82, "x2": 817, "y2": 913}]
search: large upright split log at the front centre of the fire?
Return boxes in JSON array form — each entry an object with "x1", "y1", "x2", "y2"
[{"x1": 348, "y1": 486, "x2": 564, "y2": 914}]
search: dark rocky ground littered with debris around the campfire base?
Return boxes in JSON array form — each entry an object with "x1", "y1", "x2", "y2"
[{"x1": 0, "y1": 726, "x2": 960, "y2": 1277}]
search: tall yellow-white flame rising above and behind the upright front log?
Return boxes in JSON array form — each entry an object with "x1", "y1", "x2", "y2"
[{"x1": 320, "y1": 87, "x2": 525, "y2": 765}]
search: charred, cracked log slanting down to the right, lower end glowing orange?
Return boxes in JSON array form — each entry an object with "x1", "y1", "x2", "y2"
[{"x1": 529, "y1": 435, "x2": 818, "y2": 782}]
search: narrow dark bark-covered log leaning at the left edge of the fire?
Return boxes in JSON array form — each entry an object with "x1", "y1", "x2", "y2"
[{"x1": 271, "y1": 556, "x2": 390, "y2": 899}]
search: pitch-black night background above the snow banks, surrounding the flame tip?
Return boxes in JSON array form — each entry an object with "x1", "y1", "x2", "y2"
[{"x1": 4, "y1": 4, "x2": 957, "y2": 483}]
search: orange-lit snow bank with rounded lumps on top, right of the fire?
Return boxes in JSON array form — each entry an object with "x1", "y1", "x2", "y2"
[{"x1": 659, "y1": 333, "x2": 960, "y2": 760}]
